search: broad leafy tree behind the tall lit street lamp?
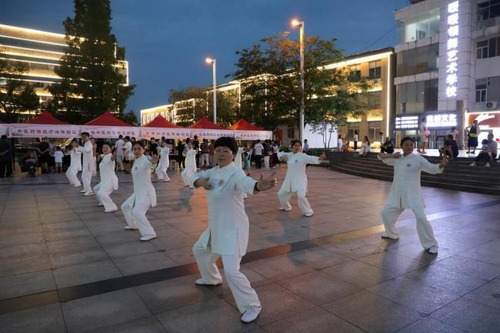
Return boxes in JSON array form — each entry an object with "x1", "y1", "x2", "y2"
[{"x1": 233, "y1": 33, "x2": 368, "y2": 139}]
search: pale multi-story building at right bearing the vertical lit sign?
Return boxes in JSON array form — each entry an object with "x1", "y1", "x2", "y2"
[{"x1": 391, "y1": 0, "x2": 500, "y2": 148}]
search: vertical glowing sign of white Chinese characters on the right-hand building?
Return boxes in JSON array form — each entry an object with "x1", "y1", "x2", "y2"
[{"x1": 446, "y1": 1, "x2": 459, "y2": 98}]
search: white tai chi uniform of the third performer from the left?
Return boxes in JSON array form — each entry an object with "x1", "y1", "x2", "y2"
[{"x1": 94, "y1": 154, "x2": 118, "y2": 213}]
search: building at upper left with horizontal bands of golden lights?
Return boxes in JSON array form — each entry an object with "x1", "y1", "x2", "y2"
[{"x1": 0, "y1": 24, "x2": 129, "y2": 113}]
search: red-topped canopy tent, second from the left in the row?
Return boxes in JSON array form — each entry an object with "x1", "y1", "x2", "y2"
[{"x1": 82, "y1": 111, "x2": 141, "y2": 139}]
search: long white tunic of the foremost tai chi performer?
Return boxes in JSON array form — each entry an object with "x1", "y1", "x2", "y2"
[{"x1": 189, "y1": 163, "x2": 257, "y2": 256}]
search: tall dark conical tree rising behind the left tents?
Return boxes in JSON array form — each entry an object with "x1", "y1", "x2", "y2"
[{"x1": 50, "y1": 0, "x2": 134, "y2": 122}]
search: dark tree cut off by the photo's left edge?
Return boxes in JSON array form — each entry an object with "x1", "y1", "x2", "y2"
[{"x1": 0, "y1": 53, "x2": 40, "y2": 123}]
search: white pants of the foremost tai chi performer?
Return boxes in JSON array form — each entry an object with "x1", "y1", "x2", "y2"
[{"x1": 193, "y1": 240, "x2": 260, "y2": 313}]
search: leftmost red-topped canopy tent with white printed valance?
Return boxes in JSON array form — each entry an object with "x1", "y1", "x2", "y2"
[{"x1": 9, "y1": 111, "x2": 80, "y2": 139}]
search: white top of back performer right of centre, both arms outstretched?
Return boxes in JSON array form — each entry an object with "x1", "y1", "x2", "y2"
[{"x1": 278, "y1": 152, "x2": 320, "y2": 192}]
